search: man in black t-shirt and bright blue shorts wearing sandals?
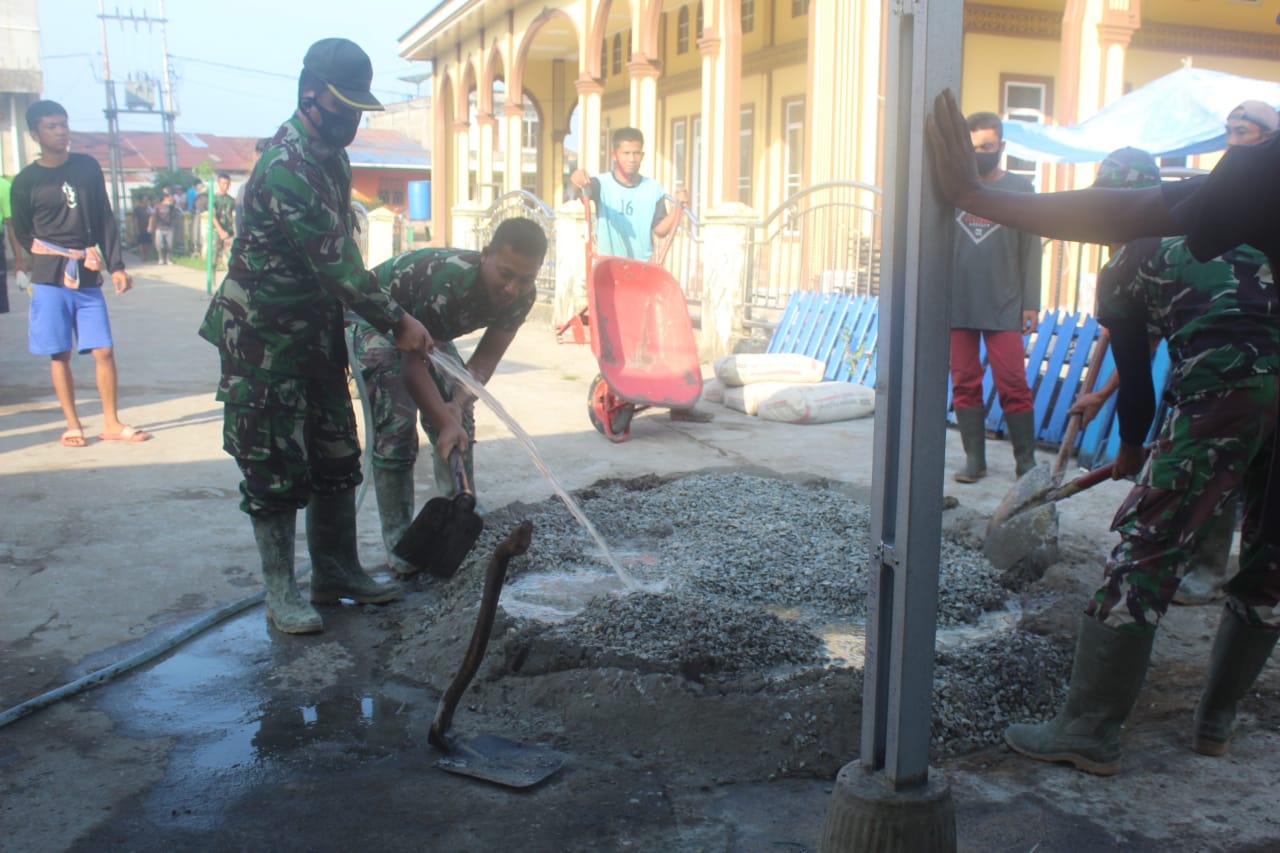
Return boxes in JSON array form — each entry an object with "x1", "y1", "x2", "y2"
[{"x1": 13, "y1": 101, "x2": 151, "y2": 447}]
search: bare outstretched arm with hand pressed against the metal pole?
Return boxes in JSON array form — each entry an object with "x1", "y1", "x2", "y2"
[{"x1": 925, "y1": 90, "x2": 1183, "y2": 243}]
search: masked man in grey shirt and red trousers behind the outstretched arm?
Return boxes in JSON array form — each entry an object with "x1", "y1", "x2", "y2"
[{"x1": 951, "y1": 113, "x2": 1041, "y2": 483}]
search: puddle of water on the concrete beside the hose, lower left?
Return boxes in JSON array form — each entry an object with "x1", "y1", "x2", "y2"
[{"x1": 100, "y1": 608, "x2": 435, "y2": 830}]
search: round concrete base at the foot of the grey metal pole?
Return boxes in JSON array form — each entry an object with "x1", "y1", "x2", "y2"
[{"x1": 820, "y1": 761, "x2": 956, "y2": 853}]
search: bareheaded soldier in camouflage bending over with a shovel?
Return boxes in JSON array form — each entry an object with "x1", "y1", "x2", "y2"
[{"x1": 353, "y1": 218, "x2": 547, "y2": 575}]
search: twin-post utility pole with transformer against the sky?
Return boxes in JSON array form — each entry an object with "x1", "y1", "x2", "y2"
[{"x1": 97, "y1": 0, "x2": 178, "y2": 227}]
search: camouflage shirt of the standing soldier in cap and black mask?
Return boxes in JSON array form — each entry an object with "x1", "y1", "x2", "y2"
[{"x1": 200, "y1": 115, "x2": 404, "y2": 377}]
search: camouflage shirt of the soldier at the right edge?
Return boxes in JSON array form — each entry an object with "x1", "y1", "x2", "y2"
[{"x1": 1098, "y1": 237, "x2": 1280, "y2": 400}]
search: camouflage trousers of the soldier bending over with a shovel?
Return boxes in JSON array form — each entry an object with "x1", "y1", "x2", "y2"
[{"x1": 352, "y1": 325, "x2": 476, "y2": 481}]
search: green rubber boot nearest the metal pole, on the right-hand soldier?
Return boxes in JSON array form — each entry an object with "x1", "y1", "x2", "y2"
[{"x1": 1005, "y1": 616, "x2": 1156, "y2": 776}]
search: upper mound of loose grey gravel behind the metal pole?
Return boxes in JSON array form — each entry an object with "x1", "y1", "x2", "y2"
[{"x1": 494, "y1": 474, "x2": 1010, "y2": 626}]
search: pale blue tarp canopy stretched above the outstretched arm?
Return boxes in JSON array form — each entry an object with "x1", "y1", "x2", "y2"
[{"x1": 1005, "y1": 68, "x2": 1280, "y2": 163}]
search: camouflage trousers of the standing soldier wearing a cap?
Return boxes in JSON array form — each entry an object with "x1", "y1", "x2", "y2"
[{"x1": 218, "y1": 360, "x2": 362, "y2": 515}]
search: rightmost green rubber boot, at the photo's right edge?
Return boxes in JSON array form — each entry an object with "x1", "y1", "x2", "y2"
[{"x1": 1192, "y1": 607, "x2": 1280, "y2": 756}]
